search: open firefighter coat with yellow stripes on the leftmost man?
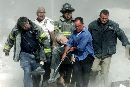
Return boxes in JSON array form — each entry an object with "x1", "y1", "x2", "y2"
[{"x1": 4, "y1": 20, "x2": 47, "y2": 62}]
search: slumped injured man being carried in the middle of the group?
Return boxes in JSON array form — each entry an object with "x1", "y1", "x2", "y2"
[{"x1": 48, "y1": 34, "x2": 73, "y2": 87}]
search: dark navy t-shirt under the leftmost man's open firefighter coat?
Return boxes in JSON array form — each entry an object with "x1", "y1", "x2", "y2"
[{"x1": 21, "y1": 28, "x2": 39, "y2": 54}]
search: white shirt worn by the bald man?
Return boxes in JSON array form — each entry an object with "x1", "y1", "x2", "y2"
[{"x1": 34, "y1": 17, "x2": 54, "y2": 40}]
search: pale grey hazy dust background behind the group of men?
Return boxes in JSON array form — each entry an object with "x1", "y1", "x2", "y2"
[{"x1": 0, "y1": 0, "x2": 130, "y2": 87}]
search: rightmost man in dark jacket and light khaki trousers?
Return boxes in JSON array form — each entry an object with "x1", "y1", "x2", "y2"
[{"x1": 89, "y1": 9, "x2": 129, "y2": 87}]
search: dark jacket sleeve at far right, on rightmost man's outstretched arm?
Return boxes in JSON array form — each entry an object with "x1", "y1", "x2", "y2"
[{"x1": 116, "y1": 24, "x2": 130, "y2": 46}]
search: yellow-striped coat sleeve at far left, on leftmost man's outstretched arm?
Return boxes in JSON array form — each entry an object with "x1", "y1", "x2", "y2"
[{"x1": 4, "y1": 26, "x2": 17, "y2": 51}]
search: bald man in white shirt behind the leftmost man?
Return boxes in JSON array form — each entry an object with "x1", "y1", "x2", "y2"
[{"x1": 34, "y1": 7, "x2": 54, "y2": 87}]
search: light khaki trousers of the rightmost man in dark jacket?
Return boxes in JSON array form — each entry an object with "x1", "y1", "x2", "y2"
[{"x1": 90, "y1": 57, "x2": 111, "y2": 87}]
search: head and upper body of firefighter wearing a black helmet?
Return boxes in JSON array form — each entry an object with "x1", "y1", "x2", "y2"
[{"x1": 55, "y1": 3, "x2": 75, "y2": 38}]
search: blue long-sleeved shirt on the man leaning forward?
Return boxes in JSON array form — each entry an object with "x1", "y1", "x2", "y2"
[{"x1": 66, "y1": 27, "x2": 94, "y2": 60}]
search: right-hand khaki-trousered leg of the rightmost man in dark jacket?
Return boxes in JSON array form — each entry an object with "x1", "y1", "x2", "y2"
[{"x1": 101, "y1": 57, "x2": 111, "y2": 87}]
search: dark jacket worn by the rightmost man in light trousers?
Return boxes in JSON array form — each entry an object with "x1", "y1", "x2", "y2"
[{"x1": 88, "y1": 19, "x2": 129, "y2": 58}]
